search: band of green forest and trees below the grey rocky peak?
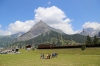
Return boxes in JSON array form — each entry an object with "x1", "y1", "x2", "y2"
[{"x1": 0, "y1": 31, "x2": 100, "y2": 50}]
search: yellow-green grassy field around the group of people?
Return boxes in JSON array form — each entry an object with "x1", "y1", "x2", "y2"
[{"x1": 0, "y1": 48, "x2": 100, "y2": 66}]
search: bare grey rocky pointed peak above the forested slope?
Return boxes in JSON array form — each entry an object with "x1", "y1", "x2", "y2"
[{"x1": 17, "y1": 20, "x2": 64, "y2": 41}]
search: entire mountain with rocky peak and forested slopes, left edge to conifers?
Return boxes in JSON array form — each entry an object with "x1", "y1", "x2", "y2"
[{"x1": 0, "y1": 20, "x2": 84, "y2": 46}]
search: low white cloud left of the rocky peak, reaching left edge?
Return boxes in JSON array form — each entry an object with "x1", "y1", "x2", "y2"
[{"x1": 0, "y1": 20, "x2": 34, "y2": 35}]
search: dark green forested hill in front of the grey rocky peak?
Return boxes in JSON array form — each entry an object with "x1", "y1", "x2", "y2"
[{"x1": 12, "y1": 30, "x2": 85, "y2": 46}]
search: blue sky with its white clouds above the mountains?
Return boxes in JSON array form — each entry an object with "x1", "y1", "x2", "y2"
[{"x1": 0, "y1": 0, "x2": 100, "y2": 35}]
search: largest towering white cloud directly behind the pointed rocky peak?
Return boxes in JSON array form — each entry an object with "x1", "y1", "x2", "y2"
[{"x1": 35, "y1": 6, "x2": 74, "y2": 34}]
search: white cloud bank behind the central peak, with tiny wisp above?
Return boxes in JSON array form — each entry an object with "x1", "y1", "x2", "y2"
[{"x1": 0, "y1": 5, "x2": 76, "y2": 35}]
